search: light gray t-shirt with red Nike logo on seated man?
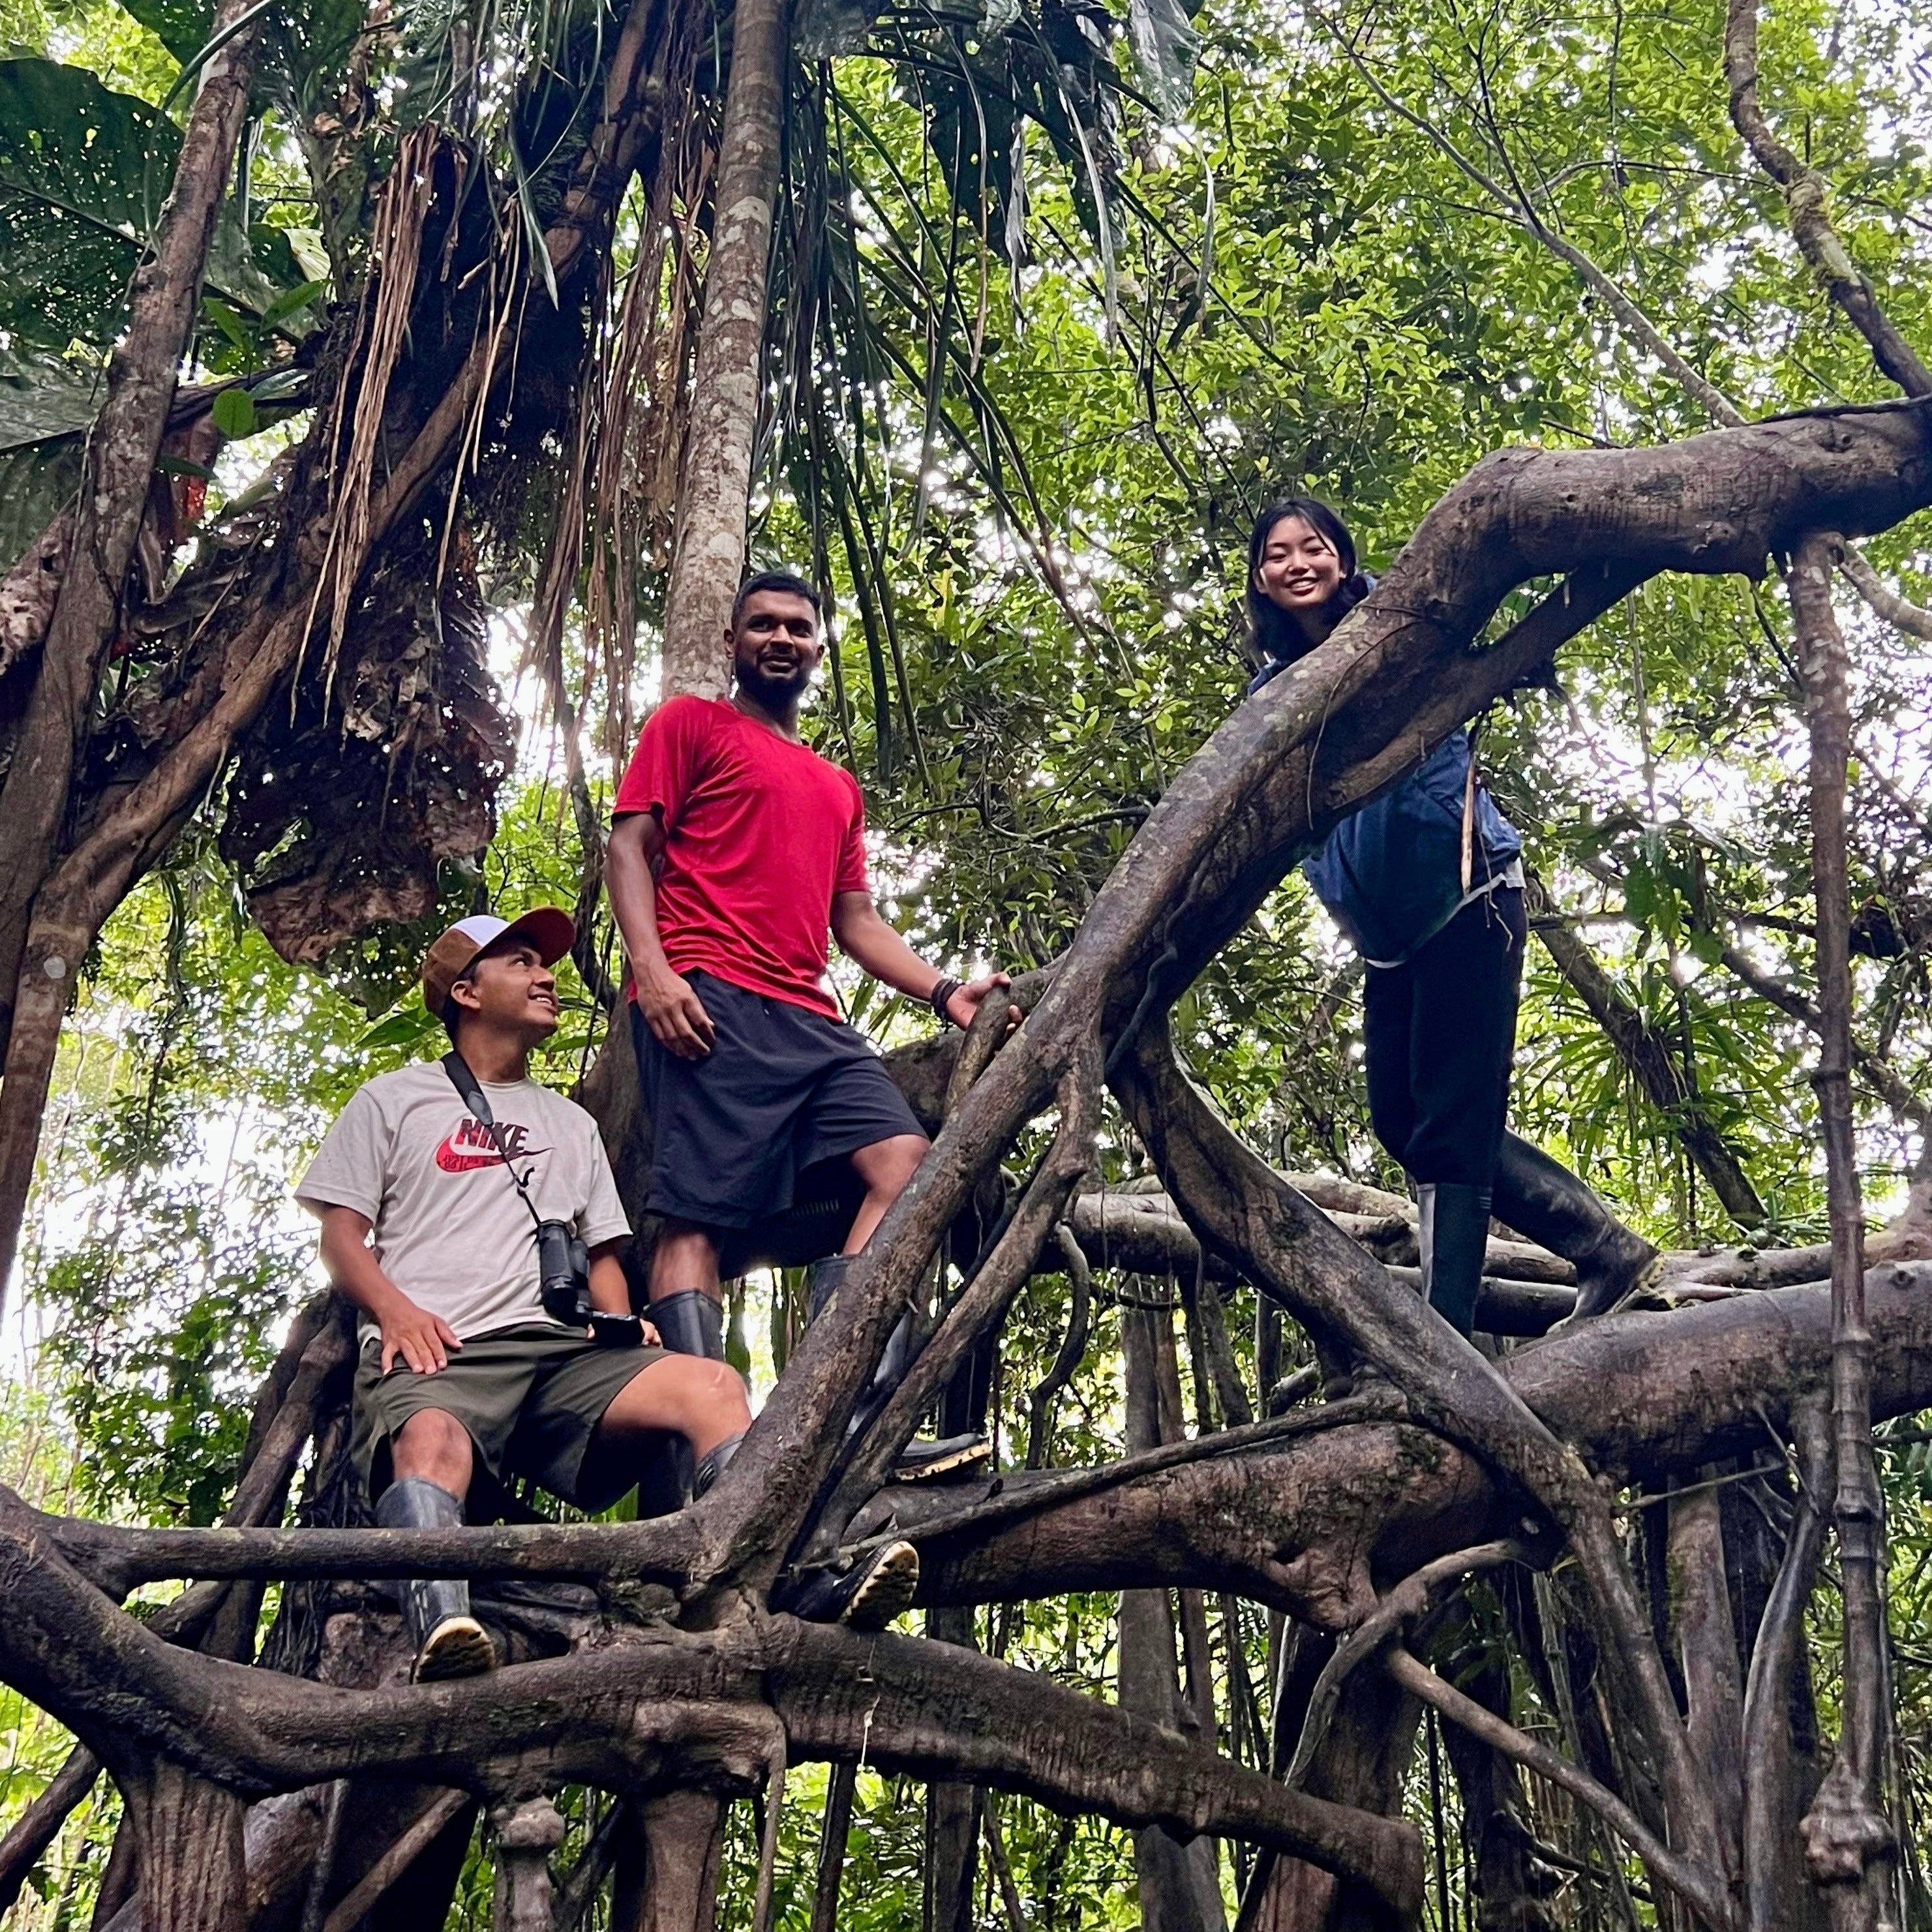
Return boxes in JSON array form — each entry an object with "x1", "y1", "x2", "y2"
[{"x1": 295, "y1": 1061, "x2": 630, "y2": 1341}]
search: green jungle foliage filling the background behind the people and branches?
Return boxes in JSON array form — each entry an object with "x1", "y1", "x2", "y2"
[{"x1": 0, "y1": 0, "x2": 1932, "y2": 1932}]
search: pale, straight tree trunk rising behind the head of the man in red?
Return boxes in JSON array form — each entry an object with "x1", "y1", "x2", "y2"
[{"x1": 663, "y1": 0, "x2": 788, "y2": 697}]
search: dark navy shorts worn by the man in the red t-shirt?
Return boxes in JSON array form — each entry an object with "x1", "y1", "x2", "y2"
[{"x1": 630, "y1": 972, "x2": 926, "y2": 1229}]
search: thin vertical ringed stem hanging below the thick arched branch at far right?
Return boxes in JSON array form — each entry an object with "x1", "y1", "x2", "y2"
[{"x1": 1791, "y1": 535, "x2": 1897, "y2": 1932}]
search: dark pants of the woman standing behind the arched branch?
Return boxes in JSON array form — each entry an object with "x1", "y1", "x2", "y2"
[{"x1": 1362, "y1": 885, "x2": 1526, "y2": 1188}]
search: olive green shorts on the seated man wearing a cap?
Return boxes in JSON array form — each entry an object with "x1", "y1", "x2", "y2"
[{"x1": 350, "y1": 1321, "x2": 674, "y2": 1513}]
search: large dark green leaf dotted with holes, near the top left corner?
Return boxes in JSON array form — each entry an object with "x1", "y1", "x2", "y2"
[{"x1": 0, "y1": 60, "x2": 301, "y2": 350}]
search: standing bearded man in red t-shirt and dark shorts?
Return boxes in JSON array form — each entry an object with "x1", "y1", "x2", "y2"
[{"x1": 607, "y1": 570, "x2": 1006, "y2": 1474}]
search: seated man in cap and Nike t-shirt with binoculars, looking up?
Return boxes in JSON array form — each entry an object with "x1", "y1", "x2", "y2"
[{"x1": 295, "y1": 906, "x2": 751, "y2": 1679}]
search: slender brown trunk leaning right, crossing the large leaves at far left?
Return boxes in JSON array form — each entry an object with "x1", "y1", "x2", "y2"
[{"x1": 0, "y1": 0, "x2": 255, "y2": 1059}]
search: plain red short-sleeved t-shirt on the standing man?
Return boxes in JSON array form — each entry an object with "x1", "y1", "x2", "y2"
[{"x1": 612, "y1": 697, "x2": 866, "y2": 1020}]
